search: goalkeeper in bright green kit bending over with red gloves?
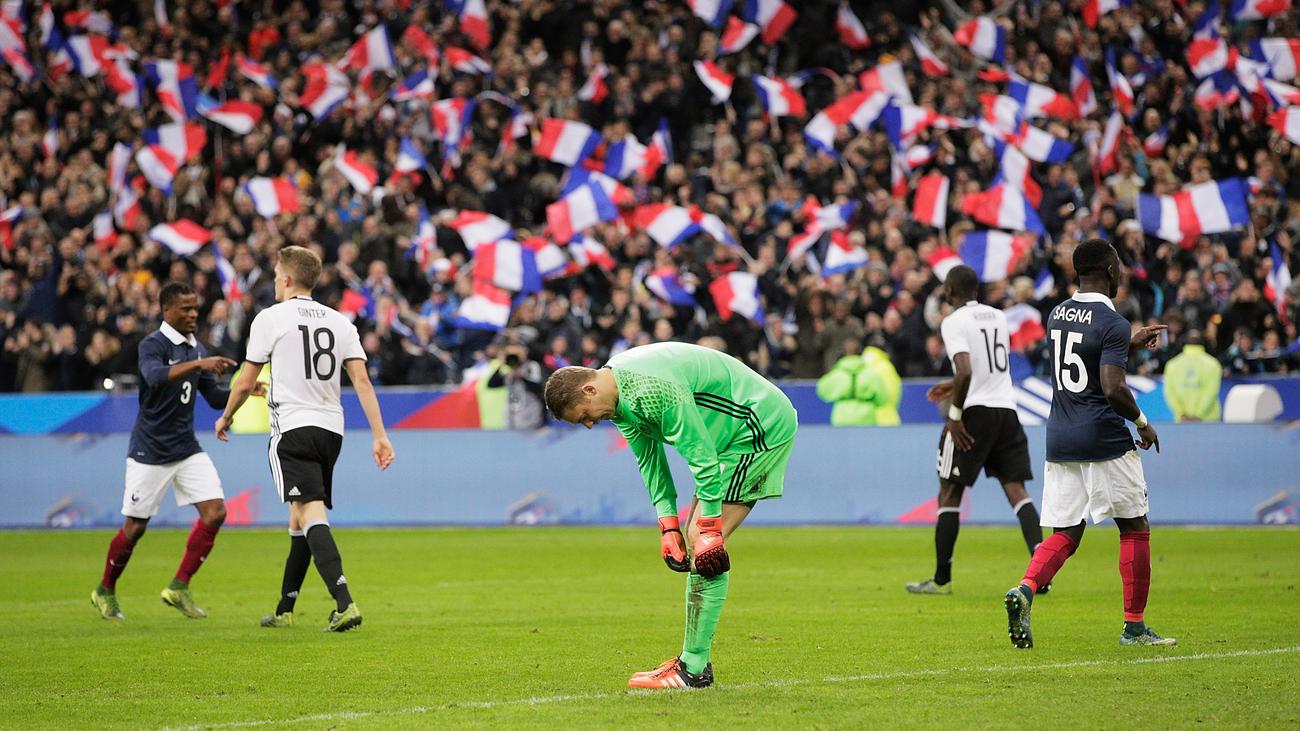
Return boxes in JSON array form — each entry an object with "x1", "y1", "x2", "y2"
[{"x1": 546, "y1": 342, "x2": 798, "y2": 688}]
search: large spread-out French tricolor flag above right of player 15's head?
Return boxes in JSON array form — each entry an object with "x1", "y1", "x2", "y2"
[{"x1": 1138, "y1": 178, "x2": 1251, "y2": 248}]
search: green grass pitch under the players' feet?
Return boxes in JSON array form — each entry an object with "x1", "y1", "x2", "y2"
[{"x1": 0, "y1": 527, "x2": 1300, "y2": 728}]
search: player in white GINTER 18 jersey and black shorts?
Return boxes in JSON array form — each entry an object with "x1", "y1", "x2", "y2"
[{"x1": 216, "y1": 246, "x2": 393, "y2": 632}]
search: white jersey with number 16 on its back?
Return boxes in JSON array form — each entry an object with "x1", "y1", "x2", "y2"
[{"x1": 939, "y1": 300, "x2": 1015, "y2": 408}]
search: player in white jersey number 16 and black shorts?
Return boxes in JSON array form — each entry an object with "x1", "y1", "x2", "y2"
[{"x1": 907, "y1": 267, "x2": 1047, "y2": 594}]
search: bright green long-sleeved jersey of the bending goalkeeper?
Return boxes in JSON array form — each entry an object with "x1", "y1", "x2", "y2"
[{"x1": 606, "y1": 342, "x2": 798, "y2": 518}]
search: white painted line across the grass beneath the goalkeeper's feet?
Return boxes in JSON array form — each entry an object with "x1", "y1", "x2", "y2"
[{"x1": 166, "y1": 646, "x2": 1300, "y2": 731}]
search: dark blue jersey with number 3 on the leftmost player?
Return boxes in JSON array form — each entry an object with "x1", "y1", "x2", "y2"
[{"x1": 127, "y1": 323, "x2": 230, "y2": 464}]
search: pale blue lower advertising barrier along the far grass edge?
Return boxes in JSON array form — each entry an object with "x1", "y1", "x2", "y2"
[{"x1": 0, "y1": 424, "x2": 1300, "y2": 528}]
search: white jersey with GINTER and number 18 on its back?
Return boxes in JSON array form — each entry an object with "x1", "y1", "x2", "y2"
[{"x1": 246, "y1": 297, "x2": 365, "y2": 434}]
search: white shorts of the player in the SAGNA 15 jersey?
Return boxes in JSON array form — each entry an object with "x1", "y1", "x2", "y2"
[{"x1": 1039, "y1": 449, "x2": 1151, "y2": 528}]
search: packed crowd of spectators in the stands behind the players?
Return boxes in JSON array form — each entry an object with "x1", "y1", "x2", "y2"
[{"x1": 0, "y1": 0, "x2": 1300, "y2": 392}]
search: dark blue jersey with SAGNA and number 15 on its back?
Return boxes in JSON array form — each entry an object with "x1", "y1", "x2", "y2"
[{"x1": 1047, "y1": 293, "x2": 1134, "y2": 462}]
